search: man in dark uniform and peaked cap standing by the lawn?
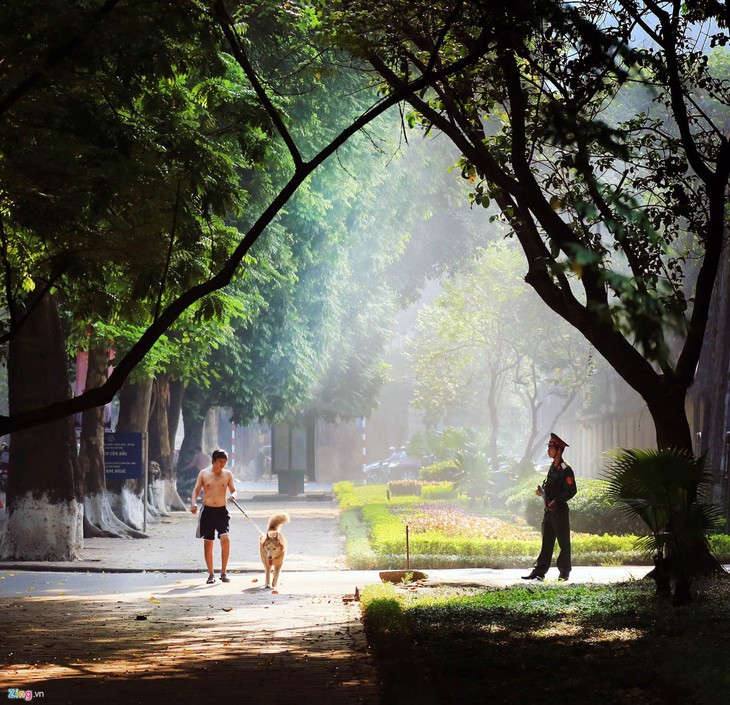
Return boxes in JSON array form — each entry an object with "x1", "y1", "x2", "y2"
[{"x1": 522, "y1": 433, "x2": 577, "y2": 580}]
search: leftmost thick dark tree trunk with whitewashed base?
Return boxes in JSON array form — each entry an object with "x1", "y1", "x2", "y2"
[{"x1": 0, "y1": 296, "x2": 83, "y2": 561}]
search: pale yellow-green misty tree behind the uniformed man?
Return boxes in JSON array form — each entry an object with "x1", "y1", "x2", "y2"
[{"x1": 412, "y1": 241, "x2": 592, "y2": 473}]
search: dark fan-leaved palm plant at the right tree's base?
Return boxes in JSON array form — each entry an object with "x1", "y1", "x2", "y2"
[{"x1": 605, "y1": 449, "x2": 723, "y2": 602}]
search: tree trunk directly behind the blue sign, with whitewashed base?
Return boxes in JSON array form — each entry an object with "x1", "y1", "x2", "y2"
[{"x1": 107, "y1": 378, "x2": 152, "y2": 531}]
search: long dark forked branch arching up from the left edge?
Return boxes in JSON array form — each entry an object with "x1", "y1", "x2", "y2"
[{"x1": 0, "y1": 0, "x2": 484, "y2": 434}]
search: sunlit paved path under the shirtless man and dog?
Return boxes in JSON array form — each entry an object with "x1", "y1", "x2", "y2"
[{"x1": 0, "y1": 497, "x2": 648, "y2": 705}]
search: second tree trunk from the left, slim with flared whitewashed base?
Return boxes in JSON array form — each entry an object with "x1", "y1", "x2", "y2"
[{"x1": 79, "y1": 345, "x2": 144, "y2": 538}]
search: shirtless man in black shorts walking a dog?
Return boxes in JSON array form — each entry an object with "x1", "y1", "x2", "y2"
[{"x1": 190, "y1": 450, "x2": 236, "y2": 584}]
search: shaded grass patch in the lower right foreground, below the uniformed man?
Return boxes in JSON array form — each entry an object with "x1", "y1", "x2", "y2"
[{"x1": 362, "y1": 578, "x2": 730, "y2": 705}]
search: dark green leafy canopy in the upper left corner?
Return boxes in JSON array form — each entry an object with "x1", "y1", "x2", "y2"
[{"x1": 0, "y1": 2, "x2": 258, "y2": 326}]
